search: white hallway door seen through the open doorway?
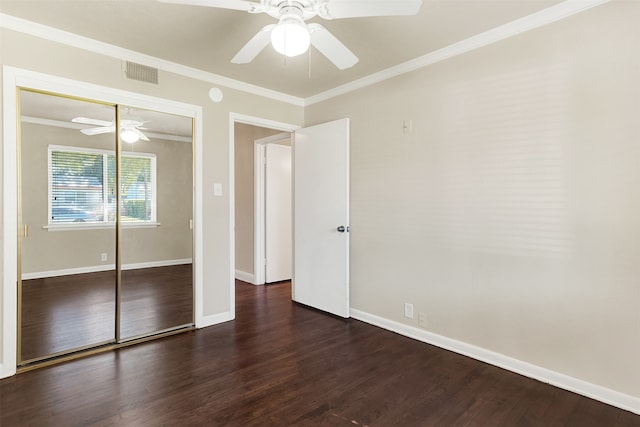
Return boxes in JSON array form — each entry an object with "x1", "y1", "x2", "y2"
[{"x1": 265, "y1": 144, "x2": 292, "y2": 283}]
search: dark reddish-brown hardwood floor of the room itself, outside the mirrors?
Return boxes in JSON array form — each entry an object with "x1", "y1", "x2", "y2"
[{"x1": 0, "y1": 282, "x2": 640, "y2": 427}]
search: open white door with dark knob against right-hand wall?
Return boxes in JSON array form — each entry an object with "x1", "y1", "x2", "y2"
[{"x1": 292, "y1": 119, "x2": 349, "y2": 317}]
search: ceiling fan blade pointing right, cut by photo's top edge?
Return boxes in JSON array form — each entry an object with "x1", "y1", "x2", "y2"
[{"x1": 318, "y1": 0, "x2": 422, "y2": 19}]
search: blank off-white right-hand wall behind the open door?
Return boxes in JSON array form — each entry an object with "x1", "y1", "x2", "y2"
[{"x1": 305, "y1": 2, "x2": 640, "y2": 411}]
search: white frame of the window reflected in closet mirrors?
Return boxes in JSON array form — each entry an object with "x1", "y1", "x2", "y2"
[{"x1": 43, "y1": 144, "x2": 160, "y2": 231}]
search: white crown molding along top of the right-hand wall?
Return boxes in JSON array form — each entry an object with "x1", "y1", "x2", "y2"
[{"x1": 304, "y1": 0, "x2": 610, "y2": 106}]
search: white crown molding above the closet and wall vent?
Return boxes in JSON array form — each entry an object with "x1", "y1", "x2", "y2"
[{"x1": 0, "y1": 13, "x2": 304, "y2": 107}]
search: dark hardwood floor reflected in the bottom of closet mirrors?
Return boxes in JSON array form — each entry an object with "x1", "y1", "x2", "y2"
[{"x1": 21, "y1": 264, "x2": 193, "y2": 360}]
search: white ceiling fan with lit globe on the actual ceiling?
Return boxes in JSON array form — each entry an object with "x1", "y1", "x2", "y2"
[{"x1": 159, "y1": 0, "x2": 422, "y2": 70}]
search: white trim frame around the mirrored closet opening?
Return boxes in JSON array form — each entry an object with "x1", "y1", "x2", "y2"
[{"x1": 0, "y1": 66, "x2": 205, "y2": 378}]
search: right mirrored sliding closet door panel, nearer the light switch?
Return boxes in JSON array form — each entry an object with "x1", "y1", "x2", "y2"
[{"x1": 120, "y1": 107, "x2": 193, "y2": 340}]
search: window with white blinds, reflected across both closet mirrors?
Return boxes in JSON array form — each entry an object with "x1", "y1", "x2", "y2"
[{"x1": 48, "y1": 146, "x2": 156, "y2": 224}]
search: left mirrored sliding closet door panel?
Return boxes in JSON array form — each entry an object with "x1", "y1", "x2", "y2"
[{"x1": 19, "y1": 90, "x2": 116, "y2": 362}]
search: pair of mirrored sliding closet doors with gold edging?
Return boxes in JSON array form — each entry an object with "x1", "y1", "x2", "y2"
[{"x1": 18, "y1": 89, "x2": 193, "y2": 366}]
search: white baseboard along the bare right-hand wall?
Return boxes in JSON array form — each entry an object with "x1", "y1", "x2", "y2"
[{"x1": 351, "y1": 308, "x2": 640, "y2": 414}]
